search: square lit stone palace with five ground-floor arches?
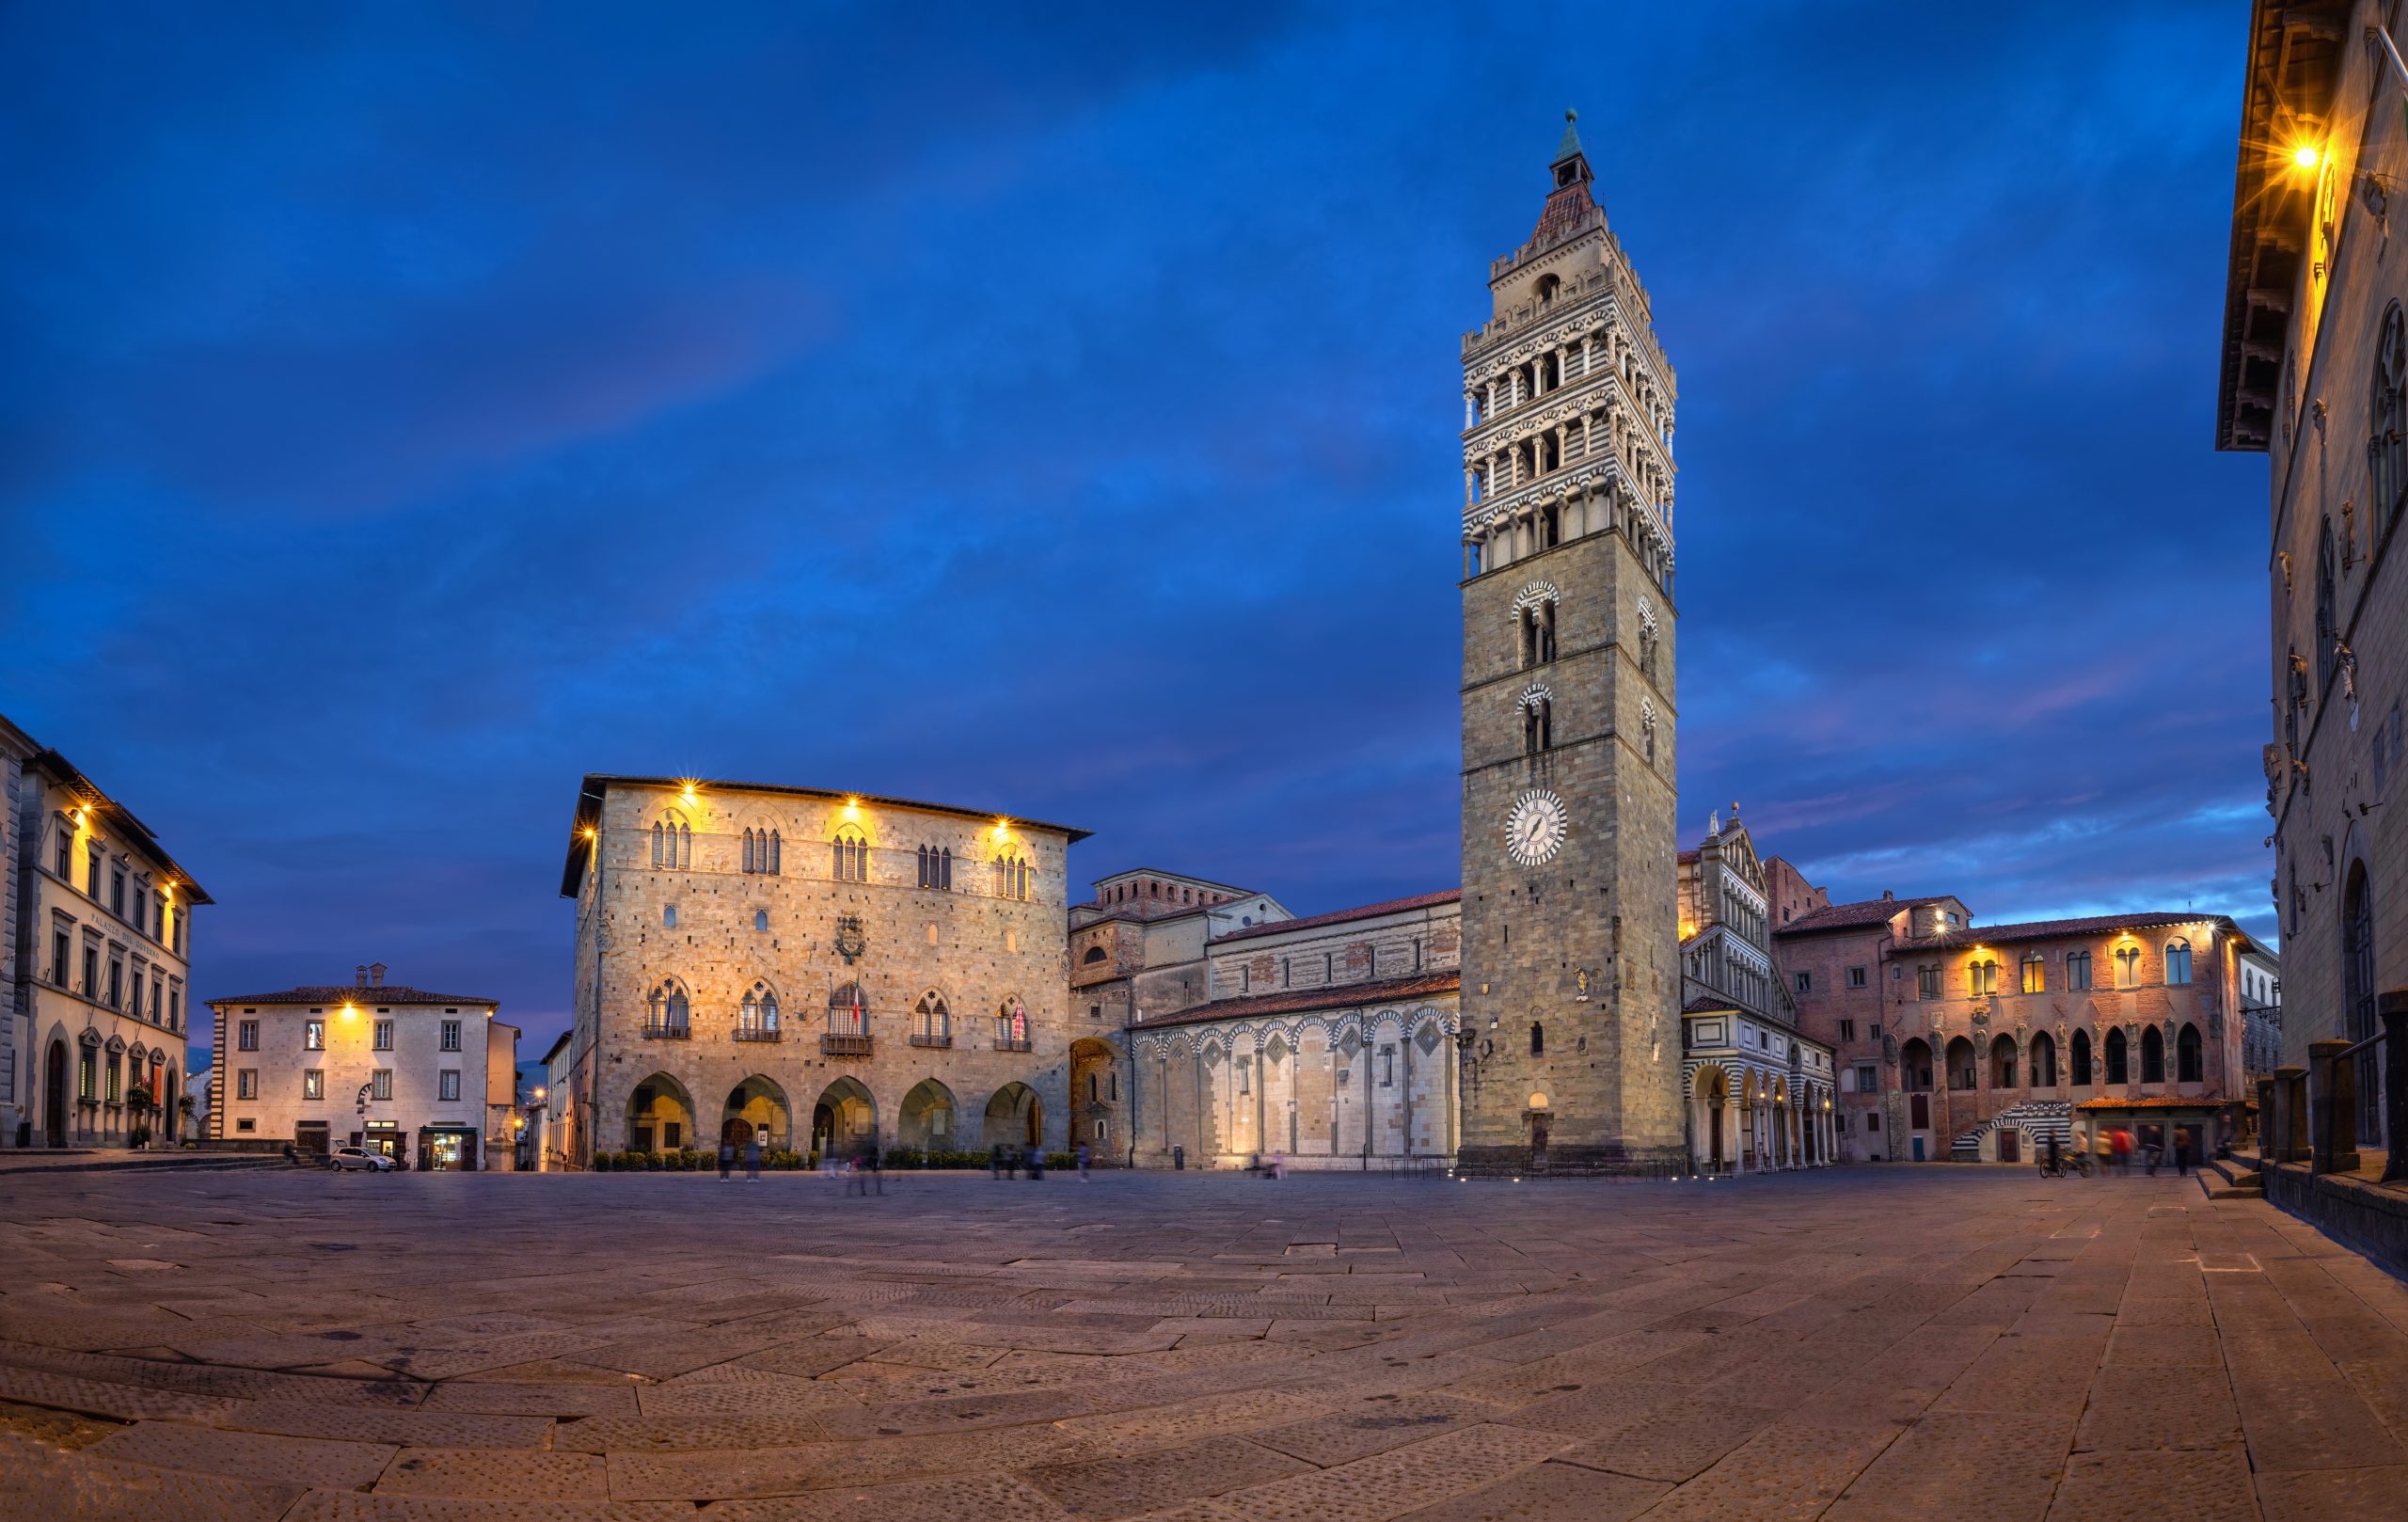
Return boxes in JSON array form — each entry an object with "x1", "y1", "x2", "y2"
[{"x1": 556, "y1": 775, "x2": 1088, "y2": 1164}]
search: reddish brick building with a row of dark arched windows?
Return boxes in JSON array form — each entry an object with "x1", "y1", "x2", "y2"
[{"x1": 1775, "y1": 896, "x2": 2257, "y2": 1161}]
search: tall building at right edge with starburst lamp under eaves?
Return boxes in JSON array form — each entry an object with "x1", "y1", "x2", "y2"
[{"x1": 2215, "y1": 0, "x2": 2408, "y2": 1147}]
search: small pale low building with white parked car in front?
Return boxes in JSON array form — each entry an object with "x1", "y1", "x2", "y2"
[{"x1": 207, "y1": 963, "x2": 517, "y2": 1173}]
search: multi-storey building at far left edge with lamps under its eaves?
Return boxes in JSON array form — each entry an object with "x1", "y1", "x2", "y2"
[{"x1": 0, "y1": 718, "x2": 210, "y2": 1147}]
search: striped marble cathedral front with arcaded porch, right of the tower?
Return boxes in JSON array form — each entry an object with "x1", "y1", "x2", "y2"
[{"x1": 1681, "y1": 804, "x2": 1837, "y2": 1173}]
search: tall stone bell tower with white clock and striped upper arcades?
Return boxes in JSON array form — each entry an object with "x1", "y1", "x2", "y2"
[{"x1": 1459, "y1": 111, "x2": 1686, "y2": 1173}]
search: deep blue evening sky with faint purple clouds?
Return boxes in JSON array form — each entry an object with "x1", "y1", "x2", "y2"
[{"x1": 0, "y1": 0, "x2": 2273, "y2": 1050}]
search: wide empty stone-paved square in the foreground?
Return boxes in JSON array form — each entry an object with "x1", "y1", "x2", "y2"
[{"x1": 0, "y1": 1168, "x2": 2408, "y2": 1522}]
